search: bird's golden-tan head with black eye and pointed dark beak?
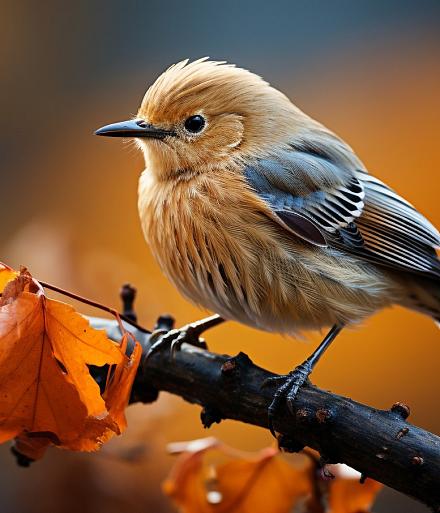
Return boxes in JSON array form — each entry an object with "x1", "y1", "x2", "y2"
[{"x1": 96, "y1": 59, "x2": 305, "y2": 179}]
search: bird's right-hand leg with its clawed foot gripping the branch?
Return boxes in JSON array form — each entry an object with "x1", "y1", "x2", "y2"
[{"x1": 263, "y1": 324, "x2": 343, "y2": 436}]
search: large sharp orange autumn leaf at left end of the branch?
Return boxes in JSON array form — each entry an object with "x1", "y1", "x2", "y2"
[{"x1": 0, "y1": 266, "x2": 141, "y2": 459}]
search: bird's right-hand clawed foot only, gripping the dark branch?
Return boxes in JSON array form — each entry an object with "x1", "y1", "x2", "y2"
[{"x1": 263, "y1": 361, "x2": 312, "y2": 437}]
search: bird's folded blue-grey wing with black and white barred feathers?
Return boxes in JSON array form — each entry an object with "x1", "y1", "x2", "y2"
[{"x1": 244, "y1": 146, "x2": 440, "y2": 277}]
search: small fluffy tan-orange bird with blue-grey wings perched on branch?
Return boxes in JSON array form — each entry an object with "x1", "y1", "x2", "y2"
[{"x1": 96, "y1": 58, "x2": 440, "y2": 431}]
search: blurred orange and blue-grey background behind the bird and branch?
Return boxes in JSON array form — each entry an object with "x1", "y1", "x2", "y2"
[{"x1": 0, "y1": 0, "x2": 440, "y2": 513}]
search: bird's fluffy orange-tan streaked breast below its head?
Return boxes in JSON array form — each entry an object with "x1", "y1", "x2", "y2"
[{"x1": 139, "y1": 166, "x2": 294, "y2": 322}]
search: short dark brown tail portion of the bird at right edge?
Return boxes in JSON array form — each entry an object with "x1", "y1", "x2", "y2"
[{"x1": 403, "y1": 276, "x2": 440, "y2": 322}]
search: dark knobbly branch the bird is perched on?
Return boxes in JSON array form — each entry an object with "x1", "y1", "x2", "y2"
[{"x1": 92, "y1": 319, "x2": 440, "y2": 512}]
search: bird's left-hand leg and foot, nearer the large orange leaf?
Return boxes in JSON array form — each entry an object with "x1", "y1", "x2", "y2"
[{"x1": 146, "y1": 315, "x2": 224, "y2": 358}]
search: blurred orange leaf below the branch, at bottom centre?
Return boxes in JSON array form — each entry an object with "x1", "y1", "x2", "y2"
[{"x1": 163, "y1": 439, "x2": 313, "y2": 513}]
